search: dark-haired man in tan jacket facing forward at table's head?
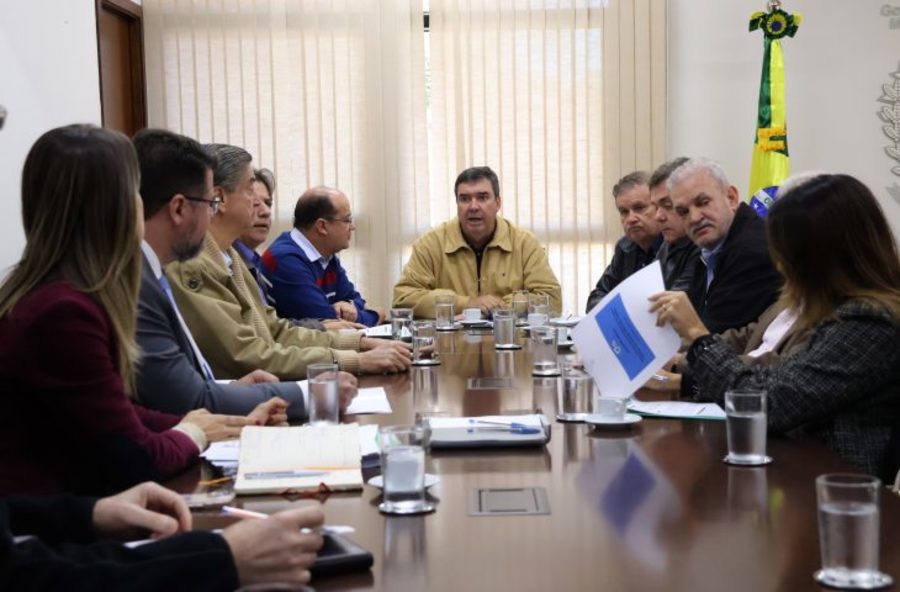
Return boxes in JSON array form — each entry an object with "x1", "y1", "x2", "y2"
[{"x1": 394, "y1": 167, "x2": 562, "y2": 318}]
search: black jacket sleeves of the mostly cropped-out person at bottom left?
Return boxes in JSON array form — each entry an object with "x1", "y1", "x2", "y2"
[{"x1": 0, "y1": 496, "x2": 239, "y2": 592}]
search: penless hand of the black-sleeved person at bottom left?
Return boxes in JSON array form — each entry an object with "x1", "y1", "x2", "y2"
[{"x1": 92, "y1": 482, "x2": 191, "y2": 541}]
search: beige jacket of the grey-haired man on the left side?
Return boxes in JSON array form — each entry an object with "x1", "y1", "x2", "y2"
[{"x1": 166, "y1": 233, "x2": 360, "y2": 380}]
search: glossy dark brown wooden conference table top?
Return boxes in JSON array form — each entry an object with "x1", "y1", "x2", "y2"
[{"x1": 169, "y1": 332, "x2": 900, "y2": 592}]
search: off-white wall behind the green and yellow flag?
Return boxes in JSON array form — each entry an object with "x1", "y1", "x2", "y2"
[{"x1": 668, "y1": 0, "x2": 900, "y2": 236}]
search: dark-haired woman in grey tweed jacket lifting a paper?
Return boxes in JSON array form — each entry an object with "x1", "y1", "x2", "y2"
[{"x1": 651, "y1": 174, "x2": 900, "y2": 480}]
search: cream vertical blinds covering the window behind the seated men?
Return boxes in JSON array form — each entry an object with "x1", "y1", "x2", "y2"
[{"x1": 143, "y1": 0, "x2": 665, "y2": 312}]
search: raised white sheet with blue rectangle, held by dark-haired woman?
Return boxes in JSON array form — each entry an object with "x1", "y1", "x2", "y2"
[{"x1": 572, "y1": 261, "x2": 681, "y2": 397}]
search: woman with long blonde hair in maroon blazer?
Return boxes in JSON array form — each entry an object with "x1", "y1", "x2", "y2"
[{"x1": 0, "y1": 125, "x2": 283, "y2": 494}]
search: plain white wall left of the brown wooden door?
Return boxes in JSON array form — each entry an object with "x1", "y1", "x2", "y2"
[{"x1": 0, "y1": 0, "x2": 101, "y2": 273}]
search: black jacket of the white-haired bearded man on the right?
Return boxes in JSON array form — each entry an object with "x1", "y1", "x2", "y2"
[{"x1": 688, "y1": 203, "x2": 781, "y2": 333}]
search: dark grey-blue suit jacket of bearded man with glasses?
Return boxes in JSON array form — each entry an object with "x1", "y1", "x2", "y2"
[{"x1": 137, "y1": 258, "x2": 306, "y2": 419}]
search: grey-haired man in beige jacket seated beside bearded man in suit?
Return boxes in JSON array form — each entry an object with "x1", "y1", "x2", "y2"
[{"x1": 166, "y1": 144, "x2": 410, "y2": 380}]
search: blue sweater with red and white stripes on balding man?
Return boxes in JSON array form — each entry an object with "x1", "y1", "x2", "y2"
[{"x1": 262, "y1": 232, "x2": 378, "y2": 327}]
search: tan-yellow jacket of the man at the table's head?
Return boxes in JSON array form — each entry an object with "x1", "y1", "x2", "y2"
[{"x1": 394, "y1": 217, "x2": 562, "y2": 318}]
